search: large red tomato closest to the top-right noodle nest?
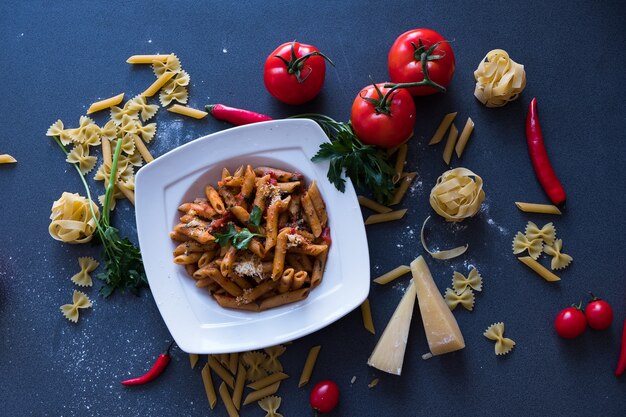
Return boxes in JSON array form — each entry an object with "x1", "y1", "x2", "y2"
[{"x1": 387, "y1": 29, "x2": 455, "y2": 96}]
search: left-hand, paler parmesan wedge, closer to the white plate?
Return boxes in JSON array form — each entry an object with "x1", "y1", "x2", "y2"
[{"x1": 367, "y1": 281, "x2": 414, "y2": 375}]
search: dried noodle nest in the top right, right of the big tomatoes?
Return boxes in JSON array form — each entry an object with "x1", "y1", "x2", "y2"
[{"x1": 474, "y1": 49, "x2": 526, "y2": 107}]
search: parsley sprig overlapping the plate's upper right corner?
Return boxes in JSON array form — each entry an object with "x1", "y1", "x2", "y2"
[{"x1": 293, "y1": 113, "x2": 395, "y2": 204}]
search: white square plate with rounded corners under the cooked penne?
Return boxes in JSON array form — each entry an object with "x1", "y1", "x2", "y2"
[{"x1": 135, "y1": 119, "x2": 370, "y2": 353}]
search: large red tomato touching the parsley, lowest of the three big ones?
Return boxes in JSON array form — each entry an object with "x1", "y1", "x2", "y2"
[{"x1": 350, "y1": 83, "x2": 416, "y2": 149}]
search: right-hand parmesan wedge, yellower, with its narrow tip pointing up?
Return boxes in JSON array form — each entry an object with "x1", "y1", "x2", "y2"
[{"x1": 410, "y1": 256, "x2": 465, "y2": 356}]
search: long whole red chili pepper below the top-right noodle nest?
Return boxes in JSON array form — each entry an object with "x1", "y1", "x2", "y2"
[{"x1": 526, "y1": 98, "x2": 565, "y2": 206}]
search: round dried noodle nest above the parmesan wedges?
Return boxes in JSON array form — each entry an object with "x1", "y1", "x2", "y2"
[{"x1": 430, "y1": 168, "x2": 485, "y2": 222}]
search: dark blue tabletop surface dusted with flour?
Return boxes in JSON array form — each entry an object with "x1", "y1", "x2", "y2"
[{"x1": 0, "y1": 1, "x2": 626, "y2": 417}]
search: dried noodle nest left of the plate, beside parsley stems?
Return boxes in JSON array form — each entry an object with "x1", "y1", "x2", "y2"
[{"x1": 48, "y1": 192, "x2": 100, "y2": 243}]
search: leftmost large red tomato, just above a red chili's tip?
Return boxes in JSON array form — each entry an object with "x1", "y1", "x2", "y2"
[{"x1": 263, "y1": 41, "x2": 334, "y2": 104}]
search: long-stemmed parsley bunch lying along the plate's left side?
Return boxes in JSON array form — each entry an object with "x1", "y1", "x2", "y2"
[{"x1": 54, "y1": 136, "x2": 148, "y2": 298}]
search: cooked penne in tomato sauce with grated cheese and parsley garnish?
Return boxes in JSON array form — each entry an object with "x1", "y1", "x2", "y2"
[{"x1": 170, "y1": 165, "x2": 331, "y2": 311}]
